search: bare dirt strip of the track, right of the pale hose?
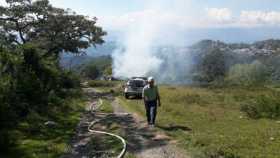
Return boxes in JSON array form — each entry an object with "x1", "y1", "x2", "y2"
[{"x1": 112, "y1": 99, "x2": 189, "y2": 158}]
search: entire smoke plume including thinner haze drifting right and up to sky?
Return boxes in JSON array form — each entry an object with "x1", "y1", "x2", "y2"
[{"x1": 113, "y1": 0, "x2": 192, "y2": 80}]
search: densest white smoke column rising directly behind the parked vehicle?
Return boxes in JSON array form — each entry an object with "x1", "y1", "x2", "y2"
[{"x1": 113, "y1": 9, "x2": 162, "y2": 77}]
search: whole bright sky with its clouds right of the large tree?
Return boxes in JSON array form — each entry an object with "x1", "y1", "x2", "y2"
[{"x1": 50, "y1": 0, "x2": 280, "y2": 28}]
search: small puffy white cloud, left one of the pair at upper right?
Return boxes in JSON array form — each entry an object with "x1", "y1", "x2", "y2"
[{"x1": 206, "y1": 8, "x2": 232, "y2": 22}]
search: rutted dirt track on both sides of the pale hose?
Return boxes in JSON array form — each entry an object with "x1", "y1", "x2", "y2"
[{"x1": 62, "y1": 88, "x2": 189, "y2": 158}]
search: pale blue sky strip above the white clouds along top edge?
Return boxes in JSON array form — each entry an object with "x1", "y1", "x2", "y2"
[{"x1": 50, "y1": 0, "x2": 280, "y2": 15}]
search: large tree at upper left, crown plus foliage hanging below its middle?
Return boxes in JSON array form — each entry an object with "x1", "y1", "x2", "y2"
[{"x1": 0, "y1": 0, "x2": 106, "y2": 91}]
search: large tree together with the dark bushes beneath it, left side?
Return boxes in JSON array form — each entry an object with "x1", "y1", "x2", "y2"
[{"x1": 0, "y1": 0, "x2": 106, "y2": 150}]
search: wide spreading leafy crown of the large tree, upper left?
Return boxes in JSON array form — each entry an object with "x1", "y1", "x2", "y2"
[{"x1": 0, "y1": 0, "x2": 106, "y2": 57}]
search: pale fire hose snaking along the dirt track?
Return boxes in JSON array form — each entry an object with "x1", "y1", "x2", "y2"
[{"x1": 88, "y1": 99, "x2": 127, "y2": 158}]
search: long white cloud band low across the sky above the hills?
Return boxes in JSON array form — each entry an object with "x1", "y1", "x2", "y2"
[{"x1": 99, "y1": 8, "x2": 280, "y2": 29}]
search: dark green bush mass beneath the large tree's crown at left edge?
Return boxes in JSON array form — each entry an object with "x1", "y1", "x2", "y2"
[{"x1": 0, "y1": 46, "x2": 83, "y2": 150}]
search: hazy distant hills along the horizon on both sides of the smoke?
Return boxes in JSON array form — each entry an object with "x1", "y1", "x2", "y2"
[{"x1": 61, "y1": 39, "x2": 280, "y2": 67}]
